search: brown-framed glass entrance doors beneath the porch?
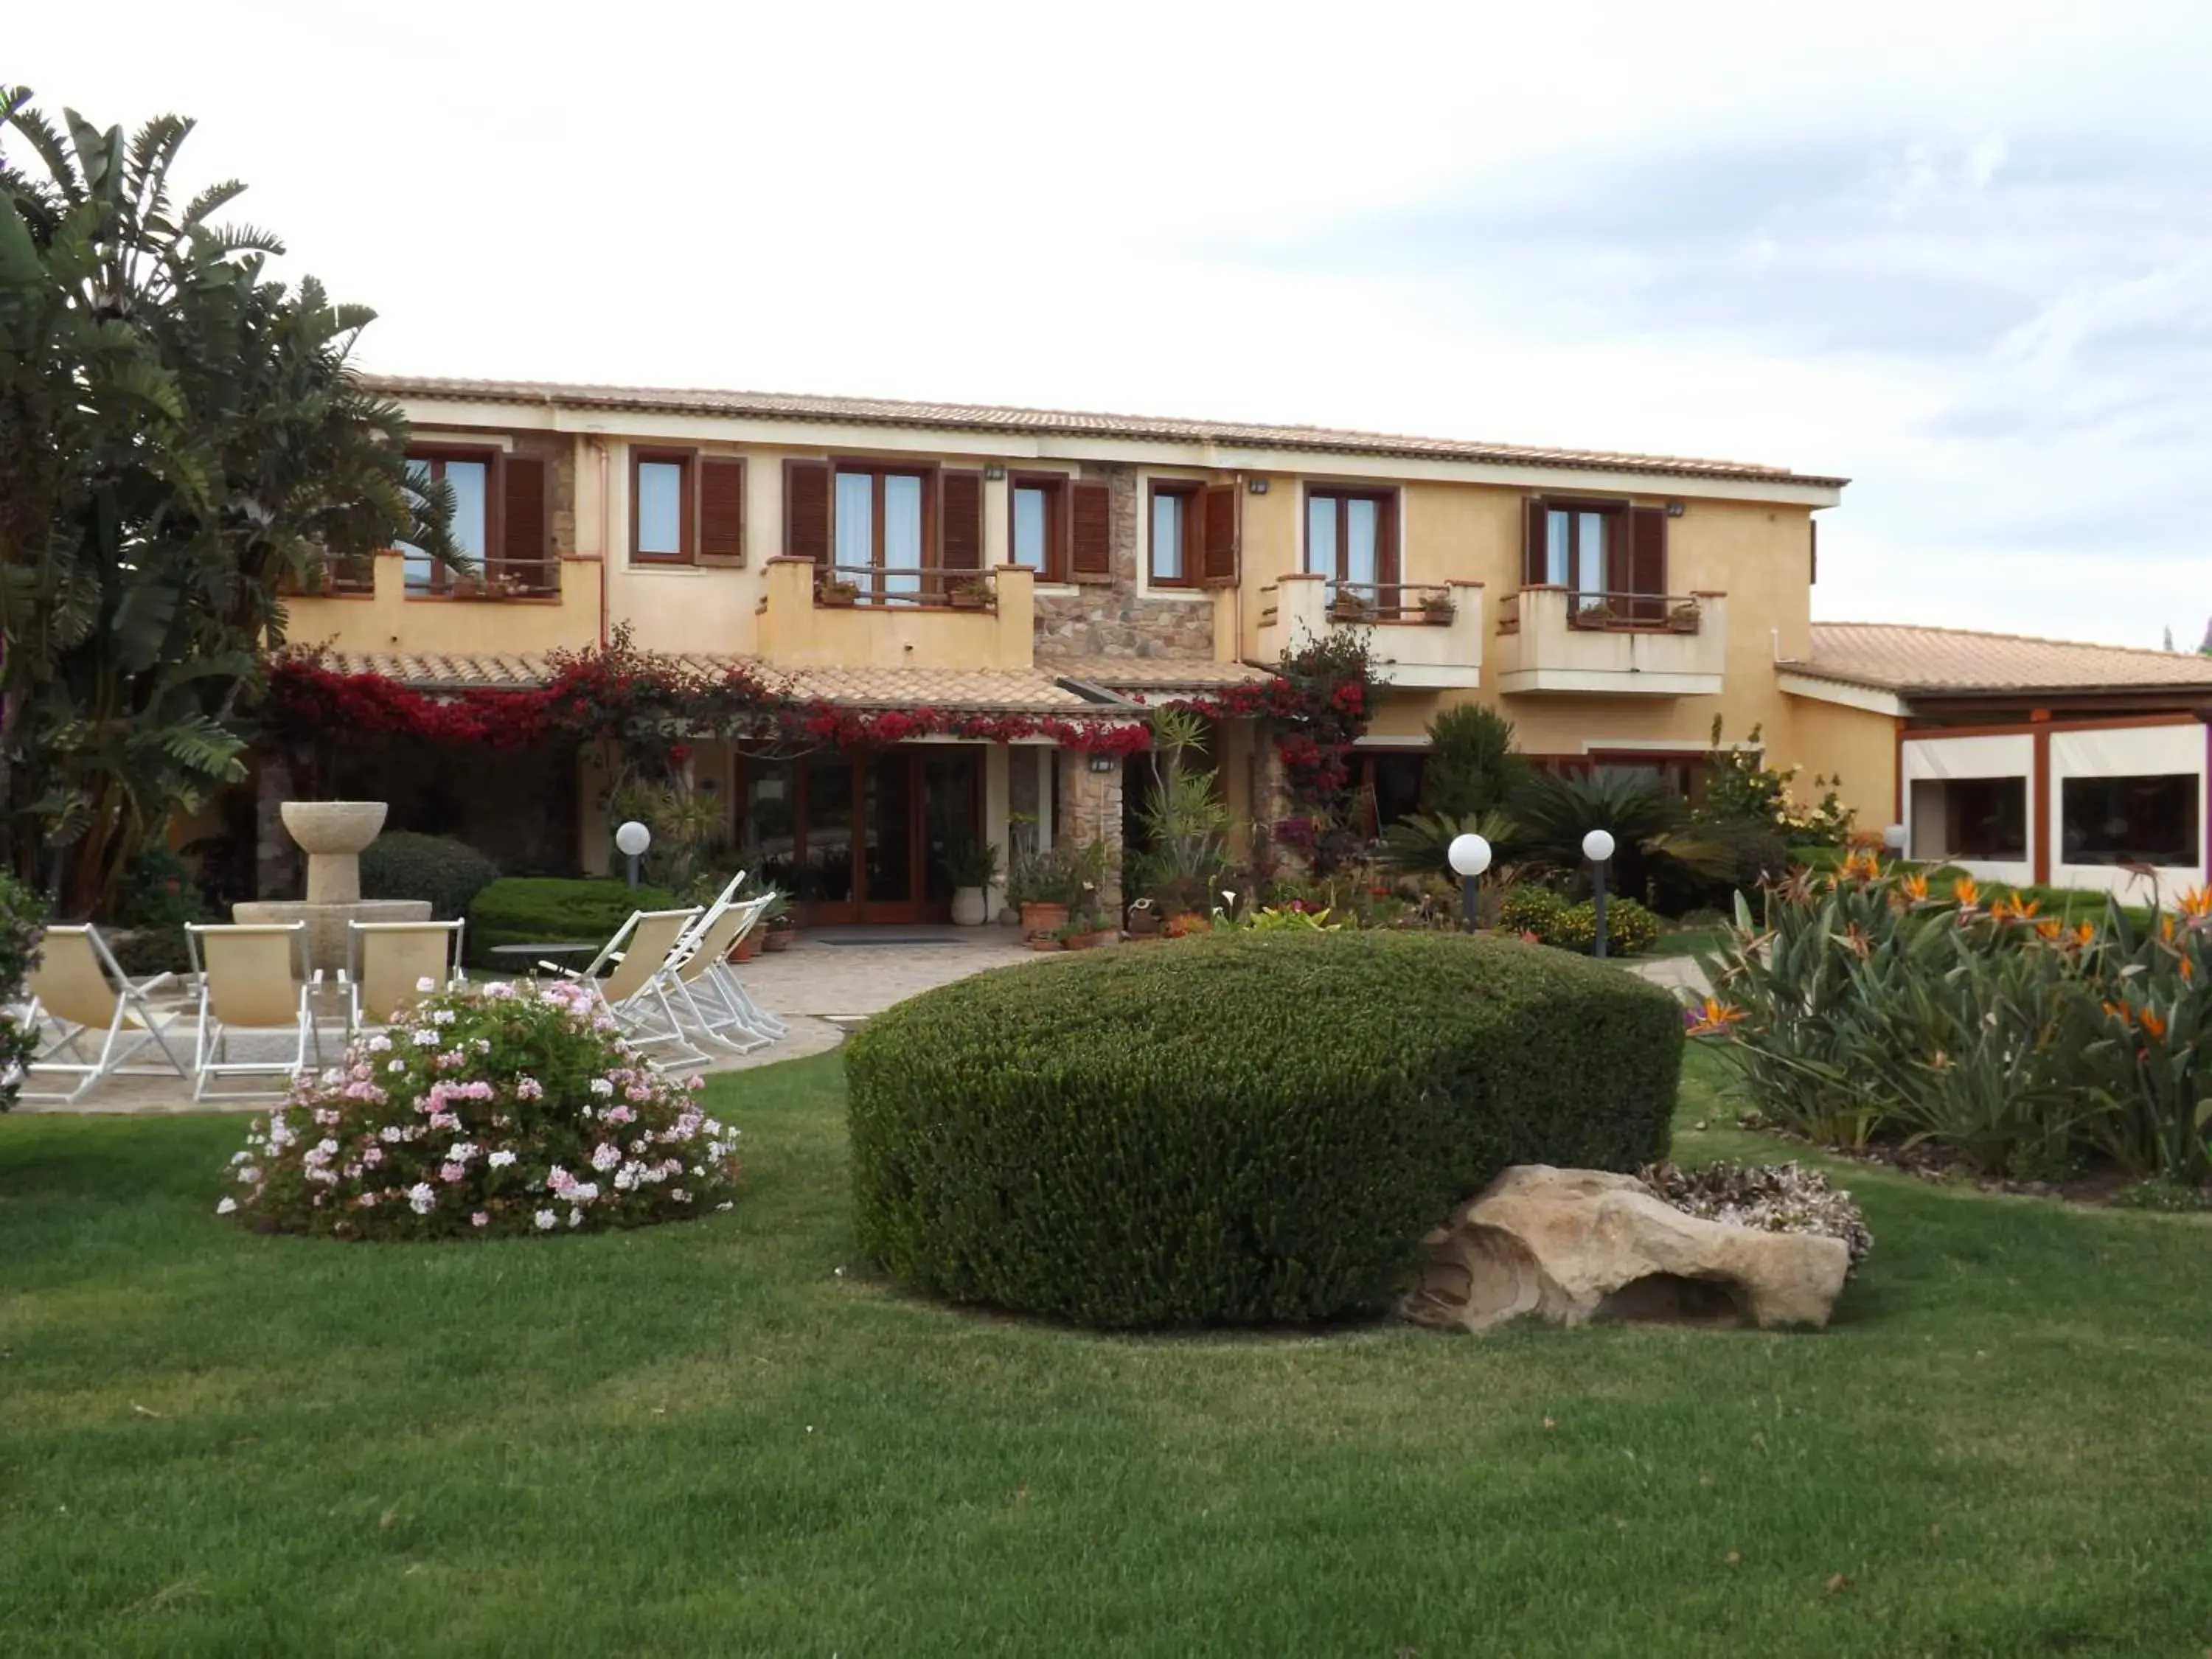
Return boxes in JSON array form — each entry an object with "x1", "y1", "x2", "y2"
[{"x1": 732, "y1": 743, "x2": 982, "y2": 925}]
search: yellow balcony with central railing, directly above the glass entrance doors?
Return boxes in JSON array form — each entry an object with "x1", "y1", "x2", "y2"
[{"x1": 759, "y1": 560, "x2": 1035, "y2": 668}]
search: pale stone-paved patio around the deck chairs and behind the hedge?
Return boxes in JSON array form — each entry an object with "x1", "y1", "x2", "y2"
[{"x1": 15, "y1": 925, "x2": 1705, "y2": 1113}]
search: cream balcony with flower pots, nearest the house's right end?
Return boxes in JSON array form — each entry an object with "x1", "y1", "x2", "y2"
[{"x1": 1498, "y1": 588, "x2": 1728, "y2": 697}]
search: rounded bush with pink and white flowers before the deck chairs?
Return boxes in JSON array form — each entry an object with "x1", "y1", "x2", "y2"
[{"x1": 217, "y1": 984, "x2": 739, "y2": 1239}]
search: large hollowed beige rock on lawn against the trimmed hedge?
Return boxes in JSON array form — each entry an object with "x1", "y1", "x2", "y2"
[{"x1": 1400, "y1": 1164, "x2": 1851, "y2": 1332}]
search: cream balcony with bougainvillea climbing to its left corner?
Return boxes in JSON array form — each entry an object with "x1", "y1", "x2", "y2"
[{"x1": 1252, "y1": 575, "x2": 1482, "y2": 688}]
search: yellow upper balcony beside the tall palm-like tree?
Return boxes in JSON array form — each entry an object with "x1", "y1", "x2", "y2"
[{"x1": 285, "y1": 549, "x2": 599, "y2": 655}]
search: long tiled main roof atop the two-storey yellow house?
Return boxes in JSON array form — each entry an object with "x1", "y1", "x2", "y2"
[{"x1": 365, "y1": 374, "x2": 1849, "y2": 489}]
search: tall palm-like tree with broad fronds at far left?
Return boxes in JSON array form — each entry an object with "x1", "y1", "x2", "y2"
[{"x1": 0, "y1": 88, "x2": 458, "y2": 914}]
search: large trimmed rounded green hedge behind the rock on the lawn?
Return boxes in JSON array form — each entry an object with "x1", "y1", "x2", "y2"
[{"x1": 845, "y1": 931, "x2": 1683, "y2": 1329}]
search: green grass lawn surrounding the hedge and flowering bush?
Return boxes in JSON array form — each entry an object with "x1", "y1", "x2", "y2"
[{"x1": 0, "y1": 1053, "x2": 2212, "y2": 1659}]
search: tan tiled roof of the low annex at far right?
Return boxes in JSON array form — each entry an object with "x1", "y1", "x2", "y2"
[{"x1": 1785, "y1": 622, "x2": 2212, "y2": 695}]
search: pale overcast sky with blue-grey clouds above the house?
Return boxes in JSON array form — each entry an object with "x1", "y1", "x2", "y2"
[{"x1": 0, "y1": 0, "x2": 2212, "y2": 648}]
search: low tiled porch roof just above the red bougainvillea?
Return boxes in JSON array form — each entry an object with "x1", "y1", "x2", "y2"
[{"x1": 325, "y1": 653, "x2": 1113, "y2": 714}]
